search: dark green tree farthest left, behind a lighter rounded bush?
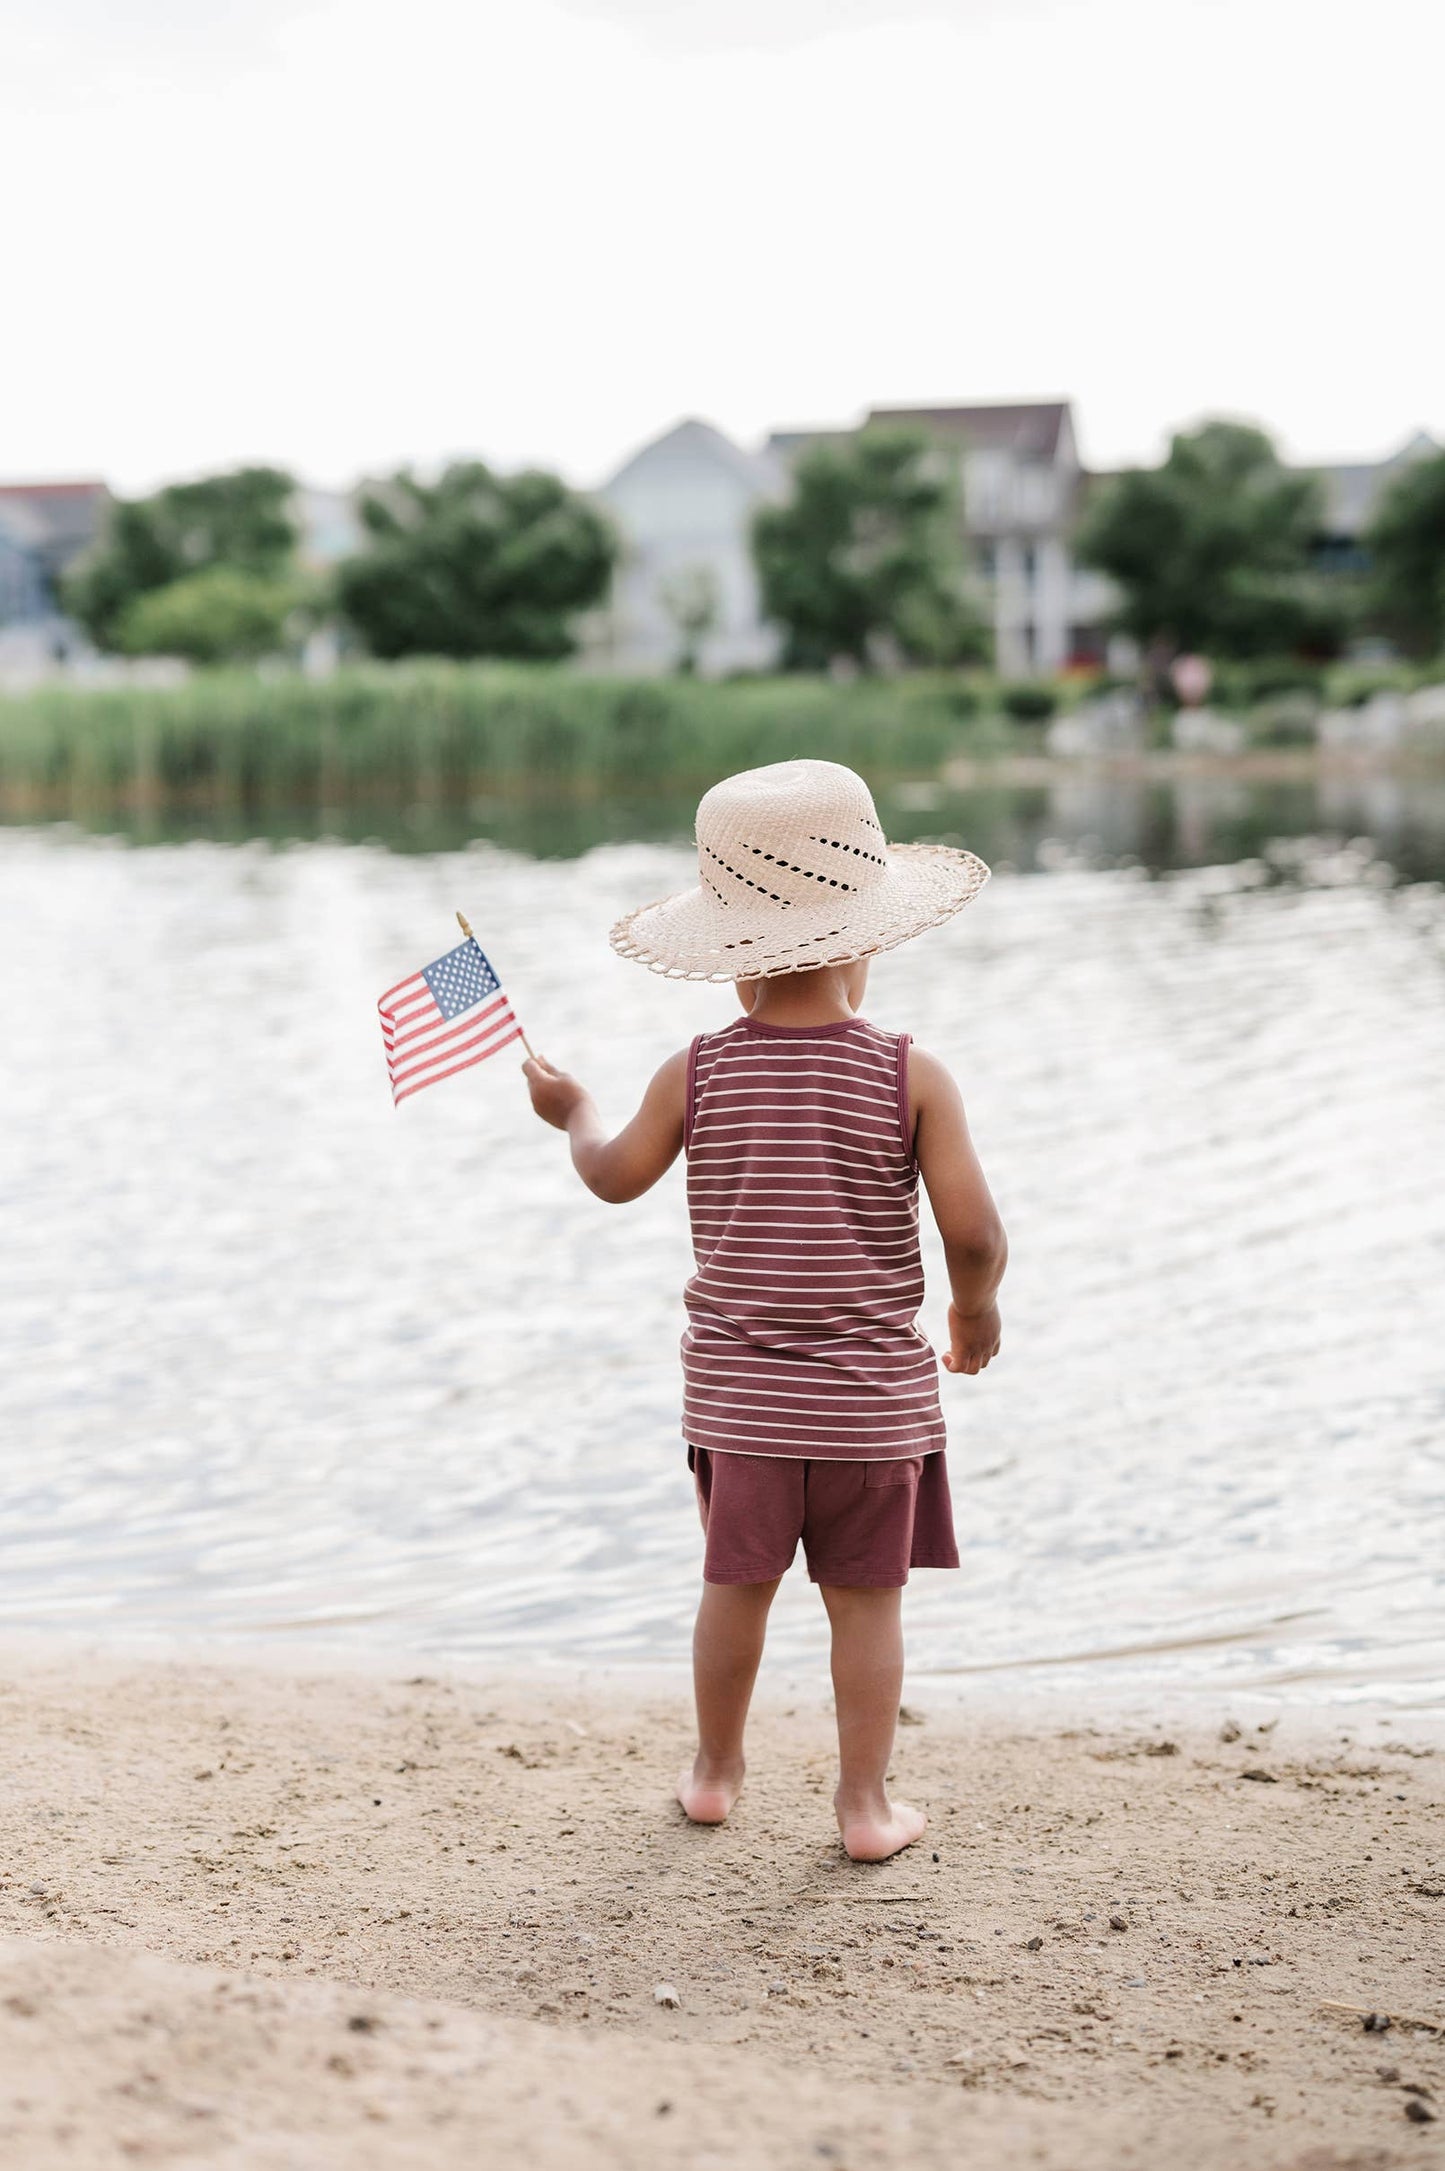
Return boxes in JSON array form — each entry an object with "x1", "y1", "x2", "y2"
[{"x1": 65, "y1": 467, "x2": 297, "y2": 649}]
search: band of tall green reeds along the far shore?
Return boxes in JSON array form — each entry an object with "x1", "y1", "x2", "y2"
[{"x1": 0, "y1": 664, "x2": 1018, "y2": 816}]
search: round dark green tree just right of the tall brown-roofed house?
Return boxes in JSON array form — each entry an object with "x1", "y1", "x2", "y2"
[{"x1": 1074, "y1": 421, "x2": 1341, "y2": 656}]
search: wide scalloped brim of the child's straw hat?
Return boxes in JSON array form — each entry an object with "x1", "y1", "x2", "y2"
[{"x1": 608, "y1": 845, "x2": 989, "y2": 979}]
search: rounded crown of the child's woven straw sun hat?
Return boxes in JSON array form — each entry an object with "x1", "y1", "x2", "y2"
[{"x1": 696, "y1": 762, "x2": 887, "y2": 912}]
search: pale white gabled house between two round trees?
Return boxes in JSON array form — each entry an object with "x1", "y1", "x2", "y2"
[{"x1": 581, "y1": 419, "x2": 785, "y2": 677}]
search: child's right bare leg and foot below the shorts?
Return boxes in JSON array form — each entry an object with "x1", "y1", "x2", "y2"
[{"x1": 822, "y1": 1587, "x2": 929, "y2": 1863}]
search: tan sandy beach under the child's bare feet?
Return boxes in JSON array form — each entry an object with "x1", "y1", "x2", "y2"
[{"x1": 0, "y1": 1643, "x2": 1445, "y2": 2171}]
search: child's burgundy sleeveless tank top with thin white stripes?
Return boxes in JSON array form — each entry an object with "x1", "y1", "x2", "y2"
[{"x1": 683, "y1": 1018, "x2": 944, "y2": 1461}]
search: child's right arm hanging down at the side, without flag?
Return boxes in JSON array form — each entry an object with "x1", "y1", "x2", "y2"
[{"x1": 909, "y1": 1049, "x2": 1009, "y2": 1372}]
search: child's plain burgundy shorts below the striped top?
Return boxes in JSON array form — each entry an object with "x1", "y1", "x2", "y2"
[{"x1": 688, "y1": 1446, "x2": 959, "y2": 1589}]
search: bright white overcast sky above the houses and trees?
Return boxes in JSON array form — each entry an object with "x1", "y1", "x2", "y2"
[{"x1": 0, "y1": 0, "x2": 1445, "y2": 491}]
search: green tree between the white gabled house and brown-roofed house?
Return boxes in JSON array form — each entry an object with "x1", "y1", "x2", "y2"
[{"x1": 753, "y1": 428, "x2": 983, "y2": 671}]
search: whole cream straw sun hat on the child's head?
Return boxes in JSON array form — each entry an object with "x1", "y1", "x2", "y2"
[{"x1": 610, "y1": 762, "x2": 989, "y2": 979}]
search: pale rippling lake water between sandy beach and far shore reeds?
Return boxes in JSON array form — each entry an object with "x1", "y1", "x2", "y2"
[{"x1": 0, "y1": 779, "x2": 1445, "y2": 1706}]
